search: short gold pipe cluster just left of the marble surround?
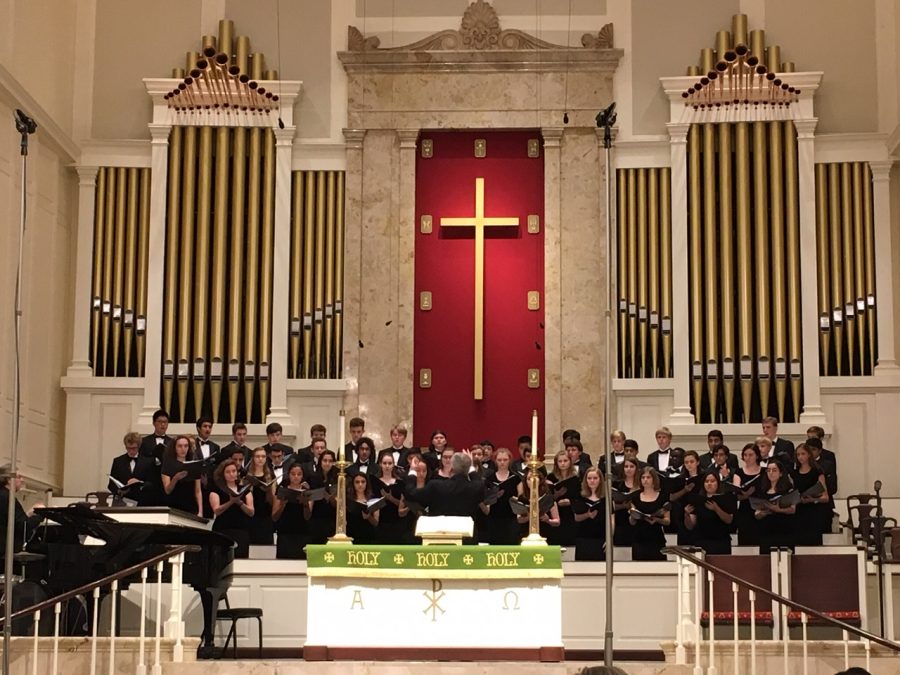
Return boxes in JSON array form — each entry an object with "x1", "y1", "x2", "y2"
[{"x1": 288, "y1": 171, "x2": 345, "y2": 379}]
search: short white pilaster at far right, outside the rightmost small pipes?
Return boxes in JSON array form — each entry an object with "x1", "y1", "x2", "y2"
[{"x1": 869, "y1": 160, "x2": 898, "y2": 374}]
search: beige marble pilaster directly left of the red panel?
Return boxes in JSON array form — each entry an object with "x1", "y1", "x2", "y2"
[{"x1": 395, "y1": 129, "x2": 419, "y2": 420}]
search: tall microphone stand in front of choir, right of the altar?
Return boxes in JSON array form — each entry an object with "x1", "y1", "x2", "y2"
[{"x1": 596, "y1": 102, "x2": 616, "y2": 668}]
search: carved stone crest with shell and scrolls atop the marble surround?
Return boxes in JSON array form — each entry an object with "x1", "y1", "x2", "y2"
[{"x1": 347, "y1": 0, "x2": 613, "y2": 52}]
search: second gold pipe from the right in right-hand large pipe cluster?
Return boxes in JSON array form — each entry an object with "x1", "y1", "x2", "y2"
[{"x1": 767, "y1": 122, "x2": 787, "y2": 420}]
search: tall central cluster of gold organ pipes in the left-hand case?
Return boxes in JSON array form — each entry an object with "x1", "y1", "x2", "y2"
[{"x1": 162, "y1": 126, "x2": 275, "y2": 422}]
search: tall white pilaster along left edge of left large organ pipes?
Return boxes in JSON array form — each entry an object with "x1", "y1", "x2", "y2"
[{"x1": 138, "y1": 124, "x2": 172, "y2": 428}]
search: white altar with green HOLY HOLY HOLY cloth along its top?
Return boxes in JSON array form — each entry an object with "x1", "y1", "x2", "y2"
[{"x1": 304, "y1": 545, "x2": 563, "y2": 661}]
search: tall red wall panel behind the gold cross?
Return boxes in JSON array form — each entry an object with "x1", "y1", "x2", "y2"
[{"x1": 413, "y1": 131, "x2": 544, "y2": 451}]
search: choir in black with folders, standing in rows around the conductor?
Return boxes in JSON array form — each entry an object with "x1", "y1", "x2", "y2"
[{"x1": 110, "y1": 411, "x2": 837, "y2": 560}]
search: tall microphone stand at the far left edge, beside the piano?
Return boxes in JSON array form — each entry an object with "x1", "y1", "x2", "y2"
[{"x1": 3, "y1": 109, "x2": 37, "y2": 675}]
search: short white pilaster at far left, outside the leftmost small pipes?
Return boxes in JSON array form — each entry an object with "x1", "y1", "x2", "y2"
[{"x1": 66, "y1": 166, "x2": 98, "y2": 377}]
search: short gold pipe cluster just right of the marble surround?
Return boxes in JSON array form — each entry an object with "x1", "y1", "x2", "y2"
[{"x1": 616, "y1": 167, "x2": 672, "y2": 378}]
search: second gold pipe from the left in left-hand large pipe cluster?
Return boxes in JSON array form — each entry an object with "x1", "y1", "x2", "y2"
[{"x1": 173, "y1": 127, "x2": 197, "y2": 422}]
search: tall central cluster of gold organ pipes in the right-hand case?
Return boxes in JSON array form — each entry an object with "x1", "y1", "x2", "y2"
[{"x1": 688, "y1": 121, "x2": 802, "y2": 423}]
